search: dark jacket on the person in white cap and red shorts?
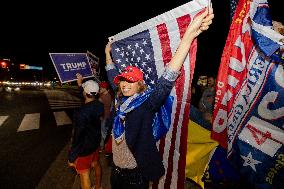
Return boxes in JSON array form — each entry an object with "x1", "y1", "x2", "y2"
[{"x1": 69, "y1": 100, "x2": 104, "y2": 162}]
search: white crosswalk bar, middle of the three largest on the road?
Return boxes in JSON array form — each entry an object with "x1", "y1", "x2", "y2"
[{"x1": 17, "y1": 113, "x2": 40, "y2": 132}]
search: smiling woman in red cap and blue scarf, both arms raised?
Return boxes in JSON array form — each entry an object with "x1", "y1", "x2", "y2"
[{"x1": 105, "y1": 10, "x2": 214, "y2": 189}]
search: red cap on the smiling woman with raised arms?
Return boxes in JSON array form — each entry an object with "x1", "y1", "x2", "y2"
[{"x1": 113, "y1": 66, "x2": 143, "y2": 85}]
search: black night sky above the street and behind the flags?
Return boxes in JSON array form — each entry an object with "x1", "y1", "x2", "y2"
[{"x1": 0, "y1": 0, "x2": 283, "y2": 80}]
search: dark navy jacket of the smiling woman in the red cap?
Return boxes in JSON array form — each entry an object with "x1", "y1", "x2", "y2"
[{"x1": 107, "y1": 69, "x2": 174, "y2": 181}]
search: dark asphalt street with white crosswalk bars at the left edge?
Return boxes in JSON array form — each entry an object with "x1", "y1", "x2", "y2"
[{"x1": 0, "y1": 90, "x2": 81, "y2": 189}]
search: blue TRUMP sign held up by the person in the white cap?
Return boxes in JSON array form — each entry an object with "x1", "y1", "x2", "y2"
[{"x1": 49, "y1": 53, "x2": 94, "y2": 83}]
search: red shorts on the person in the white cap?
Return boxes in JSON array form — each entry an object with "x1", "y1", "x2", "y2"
[{"x1": 75, "y1": 149, "x2": 99, "y2": 174}]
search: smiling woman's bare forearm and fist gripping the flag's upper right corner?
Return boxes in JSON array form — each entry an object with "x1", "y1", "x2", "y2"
[{"x1": 168, "y1": 9, "x2": 214, "y2": 71}]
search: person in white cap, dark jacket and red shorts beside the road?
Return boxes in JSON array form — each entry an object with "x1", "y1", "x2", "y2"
[{"x1": 68, "y1": 74, "x2": 104, "y2": 189}]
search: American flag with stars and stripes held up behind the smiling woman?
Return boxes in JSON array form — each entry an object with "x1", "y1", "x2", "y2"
[{"x1": 112, "y1": 0, "x2": 209, "y2": 189}]
